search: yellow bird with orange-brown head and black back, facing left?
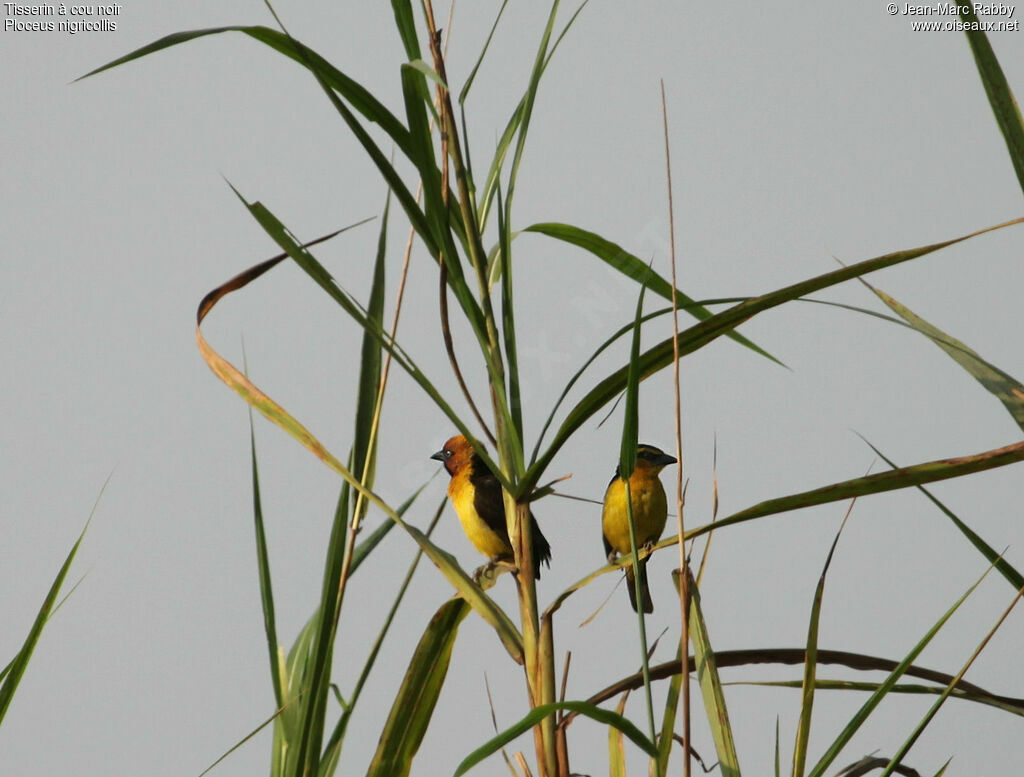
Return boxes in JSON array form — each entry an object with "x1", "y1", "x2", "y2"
[{"x1": 430, "y1": 434, "x2": 552, "y2": 579}]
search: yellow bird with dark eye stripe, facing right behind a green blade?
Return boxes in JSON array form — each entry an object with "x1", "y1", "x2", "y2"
[{"x1": 601, "y1": 444, "x2": 676, "y2": 612}]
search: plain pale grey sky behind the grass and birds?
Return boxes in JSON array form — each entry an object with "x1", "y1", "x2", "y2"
[{"x1": 0, "y1": 0, "x2": 1024, "y2": 777}]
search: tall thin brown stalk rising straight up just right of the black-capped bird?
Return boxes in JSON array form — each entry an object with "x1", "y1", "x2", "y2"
[{"x1": 660, "y1": 80, "x2": 690, "y2": 777}]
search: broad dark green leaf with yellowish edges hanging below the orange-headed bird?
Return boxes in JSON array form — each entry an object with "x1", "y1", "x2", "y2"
[{"x1": 367, "y1": 599, "x2": 469, "y2": 777}]
